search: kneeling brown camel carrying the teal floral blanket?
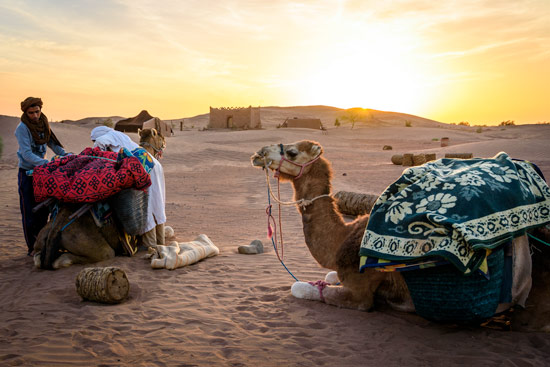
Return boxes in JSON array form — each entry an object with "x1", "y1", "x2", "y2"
[{"x1": 251, "y1": 141, "x2": 550, "y2": 331}]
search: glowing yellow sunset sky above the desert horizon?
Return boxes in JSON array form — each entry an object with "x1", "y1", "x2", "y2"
[{"x1": 0, "y1": 0, "x2": 550, "y2": 125}]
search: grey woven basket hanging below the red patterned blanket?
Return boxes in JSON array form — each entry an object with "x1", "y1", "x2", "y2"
[{"x1": 109, "y1": 189, "x2": 149, "y2": 236}]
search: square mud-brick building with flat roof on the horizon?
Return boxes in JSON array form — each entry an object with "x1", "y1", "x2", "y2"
[{"x1": 208, "y1": 106, "x2": 262, "y2": 130}]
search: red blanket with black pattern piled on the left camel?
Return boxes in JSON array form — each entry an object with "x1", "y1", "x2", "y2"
[{"x1": 33, "y1": 148, "x2": 151, "y2": 203}]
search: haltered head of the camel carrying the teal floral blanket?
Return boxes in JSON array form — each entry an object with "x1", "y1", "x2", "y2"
[{"x1": 250, "y1": 140, "x2": 323, "y2": 179}]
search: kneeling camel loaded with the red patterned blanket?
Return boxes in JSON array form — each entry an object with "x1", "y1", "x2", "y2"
[{"x1": 34, "y1": 129, "x2": 166, "y2": 269}]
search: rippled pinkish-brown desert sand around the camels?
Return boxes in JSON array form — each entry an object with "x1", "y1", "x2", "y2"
[{"x1": 0, "y1": 116, "x2": 550, "y2": 366}]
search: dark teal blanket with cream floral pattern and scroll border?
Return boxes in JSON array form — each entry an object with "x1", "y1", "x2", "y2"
[{"x1": 360, "y1": 153, "x2": 550, "y2": 274}]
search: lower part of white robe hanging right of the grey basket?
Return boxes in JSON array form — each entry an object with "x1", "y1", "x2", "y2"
[{"x1": 144, "y1": 156, "x2": 166, "y2": 233}]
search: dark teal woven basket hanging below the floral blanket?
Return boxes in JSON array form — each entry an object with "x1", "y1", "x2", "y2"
[{"x1": 402, "y1": 248, "x2": 504, "y2": 323}]
